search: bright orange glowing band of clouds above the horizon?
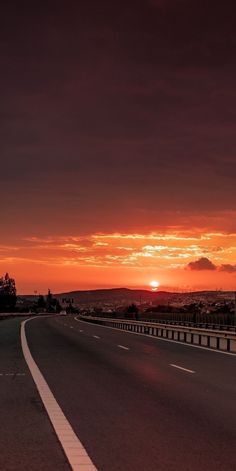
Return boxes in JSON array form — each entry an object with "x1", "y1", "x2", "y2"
[{"x1": 0, "y1": 228, "x2": 236, "y2": 291}]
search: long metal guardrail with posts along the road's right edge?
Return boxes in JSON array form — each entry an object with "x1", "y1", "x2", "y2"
[{"x1": 79, "y1": 316, "x2": 236, "y2": 354}]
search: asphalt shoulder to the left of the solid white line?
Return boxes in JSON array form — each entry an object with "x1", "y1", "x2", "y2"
[{"x1": 0, "y1": 319, "x2": 70, "y2": 471}]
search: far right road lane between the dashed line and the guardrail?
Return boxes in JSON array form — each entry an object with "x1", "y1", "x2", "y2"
[{"x1": 61, "y1": 316, "x2": 236, "y2": 395}]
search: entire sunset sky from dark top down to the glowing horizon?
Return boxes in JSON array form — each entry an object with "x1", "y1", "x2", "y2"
[{"x1": 0, "y1": 0, "x2": 236, "y2": 293}]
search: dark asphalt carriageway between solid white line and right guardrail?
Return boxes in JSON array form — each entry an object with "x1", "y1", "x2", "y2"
[{"x1": 27, "y1": 317, "x2": 236, "y2": 471}]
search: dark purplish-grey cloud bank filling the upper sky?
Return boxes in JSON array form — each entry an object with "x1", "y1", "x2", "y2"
[{"x1": 0, "y1": 0, "x2": 236, "y2": 236}]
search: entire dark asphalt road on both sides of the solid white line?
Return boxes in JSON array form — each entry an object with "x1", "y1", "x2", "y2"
[{"x1": 0, "y1": 316, "x2": 236, "y2": 471}]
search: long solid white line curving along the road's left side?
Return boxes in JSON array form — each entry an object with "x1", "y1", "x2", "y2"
[{"x1": 21, "y1": 317, "x2": 97, "y2": 471}]
